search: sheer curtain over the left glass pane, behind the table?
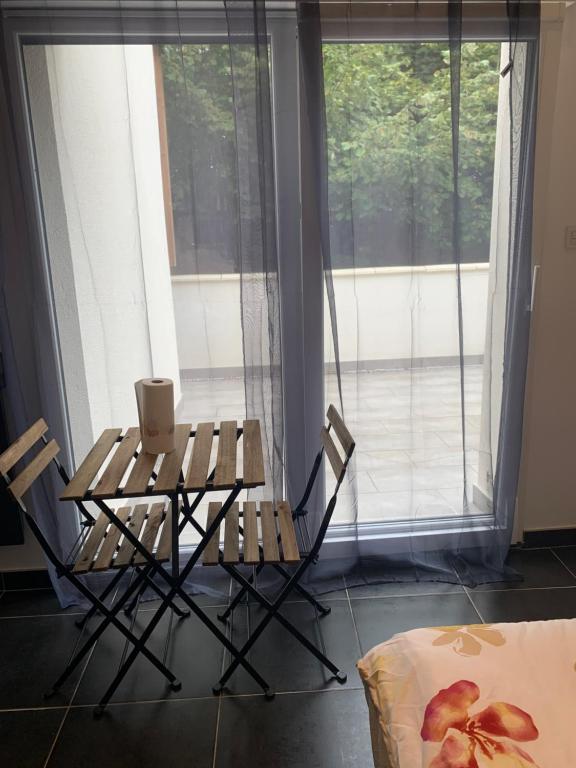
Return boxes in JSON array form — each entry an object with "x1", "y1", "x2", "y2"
[{"x1": 2, "y1": 0, "x2": 284, "y2": 600}]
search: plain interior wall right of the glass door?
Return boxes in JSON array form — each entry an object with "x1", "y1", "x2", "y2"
[{"x1": 518, "y1": 3, "x2": 576, "y2": 530}]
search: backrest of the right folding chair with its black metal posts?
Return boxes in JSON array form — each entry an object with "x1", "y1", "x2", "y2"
[{"x1": 305, "y1": 405, "x2": 356, "y2": 557}]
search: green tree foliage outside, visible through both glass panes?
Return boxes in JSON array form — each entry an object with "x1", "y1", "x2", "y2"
[{"x1": 161, "y1": 42, "x2": 500, "y2": 271}]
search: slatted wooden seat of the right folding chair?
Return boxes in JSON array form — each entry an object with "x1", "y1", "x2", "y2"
[{"x1": 202, "y1": 501, "x2": 300, "y2": 565}]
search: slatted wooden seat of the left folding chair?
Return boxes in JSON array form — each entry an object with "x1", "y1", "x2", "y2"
[{"x1": 72, "y1": 502, "x2": 172, "y2": 574}]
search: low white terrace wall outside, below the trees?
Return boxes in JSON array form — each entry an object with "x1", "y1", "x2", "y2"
[{"x1": 172, "y1": 264, "x2": 488, "y2": 371}]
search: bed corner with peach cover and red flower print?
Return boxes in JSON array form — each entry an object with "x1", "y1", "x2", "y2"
[{"x1": 358, "y1": 619, "x2": 576, "y2": 768}]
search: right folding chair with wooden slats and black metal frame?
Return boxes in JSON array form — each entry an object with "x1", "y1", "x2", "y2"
[{"x1": 203, "y1": 405, "x2": 355, "y2": 693}]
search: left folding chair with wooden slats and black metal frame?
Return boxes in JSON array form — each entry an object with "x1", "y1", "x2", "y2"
[{"x1": 0, "y1": 419, "x2": 188, "y2": 714}]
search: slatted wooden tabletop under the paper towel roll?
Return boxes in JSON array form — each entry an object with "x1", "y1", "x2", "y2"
[{"x1": 60, "y1": 419, "x2": 265, "y2": 501}]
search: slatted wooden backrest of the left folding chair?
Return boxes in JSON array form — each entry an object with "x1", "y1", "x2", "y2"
[{"x1": 0, "y1": 419, "x2": 60, "y2": 512}]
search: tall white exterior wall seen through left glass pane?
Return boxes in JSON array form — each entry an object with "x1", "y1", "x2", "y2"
[{"x1": 26, "y1": 45, "x2": 180, "y2": 457}]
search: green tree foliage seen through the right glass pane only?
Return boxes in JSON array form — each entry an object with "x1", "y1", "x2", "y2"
[{"x1": 324, "y1": 42, "x2": 500, "y2": 260}]
